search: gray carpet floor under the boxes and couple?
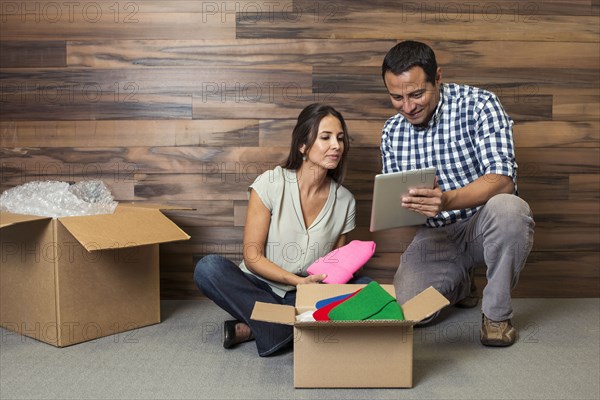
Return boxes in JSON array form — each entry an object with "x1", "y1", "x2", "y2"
[{"x1": 0, "y1": 299, "x2": 600, "y2": 400}]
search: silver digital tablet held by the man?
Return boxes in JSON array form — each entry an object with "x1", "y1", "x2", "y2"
[{"x1": 369, "y1": 167, "x2": 435, "y2": 232}]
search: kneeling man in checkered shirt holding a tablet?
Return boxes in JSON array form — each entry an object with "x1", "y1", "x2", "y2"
[{"x1": 381, "y1": 41, "x2": 535, "y2": 346}]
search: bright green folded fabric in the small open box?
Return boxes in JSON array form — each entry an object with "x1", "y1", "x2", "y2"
[{"x1": 328, "y1": 281, "x2": 403, "y2": 321}]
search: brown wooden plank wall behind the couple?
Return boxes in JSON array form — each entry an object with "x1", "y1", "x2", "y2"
[{"x1": 0, "y1": 0, "x2": 600, "y2": 299}]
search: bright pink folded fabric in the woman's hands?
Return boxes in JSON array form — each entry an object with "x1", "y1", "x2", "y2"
[{"x1": 307, "y1": 240, "x2": 375, "y2": 283}]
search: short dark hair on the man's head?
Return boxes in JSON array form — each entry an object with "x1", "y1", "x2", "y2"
[{"x1": 381, "y1": 40, "x2": 437, "y2": 85}]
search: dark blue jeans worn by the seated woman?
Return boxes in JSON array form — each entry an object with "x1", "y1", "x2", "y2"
[{"x1": 194, "y1": 254, "x2": 371, "y2": 357}]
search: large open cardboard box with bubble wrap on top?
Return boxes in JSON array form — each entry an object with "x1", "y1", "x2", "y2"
[{"x1": 0, "y1": 204, "x2": 190, "y2": 347}]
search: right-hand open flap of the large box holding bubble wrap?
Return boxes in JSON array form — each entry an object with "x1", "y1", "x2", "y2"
[{"x1": 59, "y1": 206, "x2": 190, "y2": 251}]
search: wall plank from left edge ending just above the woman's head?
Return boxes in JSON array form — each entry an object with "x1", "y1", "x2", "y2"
[{"x1": 0, "y1": 67, "x2": 312, "y2": 98}]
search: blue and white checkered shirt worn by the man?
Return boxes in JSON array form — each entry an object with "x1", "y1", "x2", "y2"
[{"x1": 381, "y1": 84, "x2": 517, "y2": 227}]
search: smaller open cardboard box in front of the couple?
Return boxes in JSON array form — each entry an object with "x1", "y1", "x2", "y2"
[{"x1": 252, "y1": 285, "x2": 449, "y2": 388}]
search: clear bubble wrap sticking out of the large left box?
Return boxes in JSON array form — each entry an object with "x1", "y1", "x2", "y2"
[{"x1": 0, "y1": 180, "x2": 118, "y2": 218}]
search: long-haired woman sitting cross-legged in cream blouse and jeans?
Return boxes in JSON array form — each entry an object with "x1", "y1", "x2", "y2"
[{"x1": 194, "y1": 104, "x2": 370, "y2": 357}]
